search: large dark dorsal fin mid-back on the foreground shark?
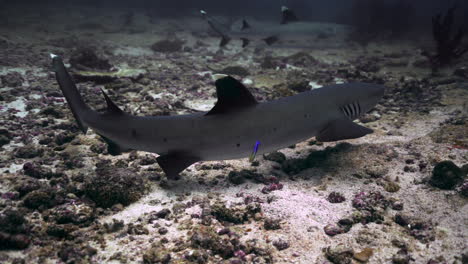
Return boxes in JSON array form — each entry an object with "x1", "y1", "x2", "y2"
[{"x1": 206, "y1": 76, "x2": 258, "y2": 115}]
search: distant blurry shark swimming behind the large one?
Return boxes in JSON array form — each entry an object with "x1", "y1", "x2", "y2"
[{"x1": 200, "y1": 6, "x2": 350, "y2": 48}]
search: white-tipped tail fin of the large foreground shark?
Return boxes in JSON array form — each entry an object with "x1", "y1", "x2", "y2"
[{"x1": 50, "y1": 54, "x2": 90, "y2": 133}]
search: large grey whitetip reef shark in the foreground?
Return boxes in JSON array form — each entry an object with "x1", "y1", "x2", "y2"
[{"x1": 51, "y1": 55, "x2": 384, "y2": 179}]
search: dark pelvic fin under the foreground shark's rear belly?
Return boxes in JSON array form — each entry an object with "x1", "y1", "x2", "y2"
[{"x1": 156, "y1": 152, "x2": 200, "y2": 180}]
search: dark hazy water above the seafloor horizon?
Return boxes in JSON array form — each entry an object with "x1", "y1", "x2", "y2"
[{"x1": 0, "y1": 0, "x2": 468, "y2": 23}]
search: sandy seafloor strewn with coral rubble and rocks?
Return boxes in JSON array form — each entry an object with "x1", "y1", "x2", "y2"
[{"x1": 0, "y1": 5, "x2": 468, "y2": 263}]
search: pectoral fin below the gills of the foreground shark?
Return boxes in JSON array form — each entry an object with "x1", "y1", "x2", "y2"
[{"x1": 316, "y1": 118, "x2": 374, "y2": 142}]
